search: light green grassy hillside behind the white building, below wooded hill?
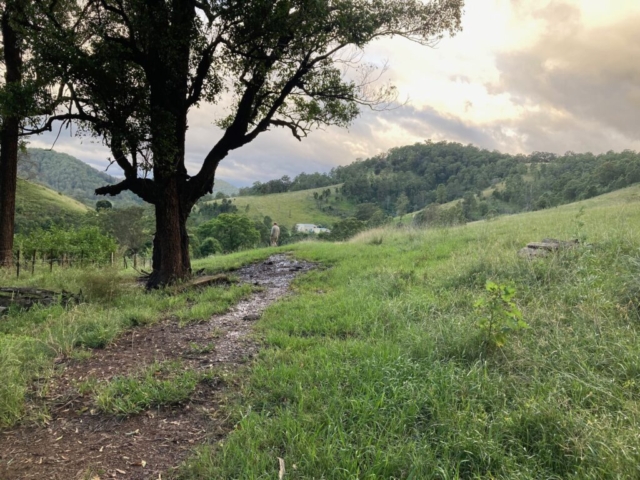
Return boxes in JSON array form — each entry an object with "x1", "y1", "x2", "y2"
[{"x1": 220, "y1": 185, "x2": 354, "y2": 227}]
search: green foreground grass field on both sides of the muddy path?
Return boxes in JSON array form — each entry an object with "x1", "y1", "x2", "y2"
[{"x1": 0, "y1": 186, "x2": 640, "y2": 480}]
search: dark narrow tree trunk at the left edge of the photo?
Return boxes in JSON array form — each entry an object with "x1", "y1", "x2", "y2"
[{"x1": 0, "y1": 5, "x2": 22, "y2": 267}]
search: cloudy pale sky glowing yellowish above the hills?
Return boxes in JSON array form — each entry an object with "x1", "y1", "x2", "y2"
[{"x1": 30, "y1": 0, "x2": 640, "y2": 186}]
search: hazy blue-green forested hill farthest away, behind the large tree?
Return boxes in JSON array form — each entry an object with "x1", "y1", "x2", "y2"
[{"x1": 18, "y1": 148, "x2": 239, "y2": 207}]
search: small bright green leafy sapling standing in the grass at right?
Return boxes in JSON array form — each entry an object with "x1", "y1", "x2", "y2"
[{"x1": 473, "y1": 281, "x2": 529, "y2": 347}]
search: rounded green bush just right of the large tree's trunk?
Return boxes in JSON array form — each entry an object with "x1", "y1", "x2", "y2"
[{"x1": 197, "y1": 213, "x2": 260, "y2": 253}]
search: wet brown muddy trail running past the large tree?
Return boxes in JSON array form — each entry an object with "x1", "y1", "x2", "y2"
[{"x1": 0, "y1": 255, "x2": 314, "y2": 480}]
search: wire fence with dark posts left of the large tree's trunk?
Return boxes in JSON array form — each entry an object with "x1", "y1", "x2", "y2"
[{"x1": 13, "y1": 250, "x2": 151, "y2": 278}]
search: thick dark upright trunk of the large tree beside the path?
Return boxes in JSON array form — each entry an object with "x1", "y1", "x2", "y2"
[{"x1": 146, "y1": 1, "x2": 196, "y2": 288}]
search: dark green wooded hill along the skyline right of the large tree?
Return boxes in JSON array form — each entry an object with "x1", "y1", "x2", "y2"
[{"x1": 242, "y1": 142, "x2": 640, "y2": 219}]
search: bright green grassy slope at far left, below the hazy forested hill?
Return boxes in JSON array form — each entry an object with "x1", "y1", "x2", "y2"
[{"x1": 16, "y1": 179, "x2": 89, "y2": 233}]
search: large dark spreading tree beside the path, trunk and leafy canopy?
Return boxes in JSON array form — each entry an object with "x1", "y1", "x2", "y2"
[{"x1": 33, "y1": 0, "x2": 463, "y2": 286}]
